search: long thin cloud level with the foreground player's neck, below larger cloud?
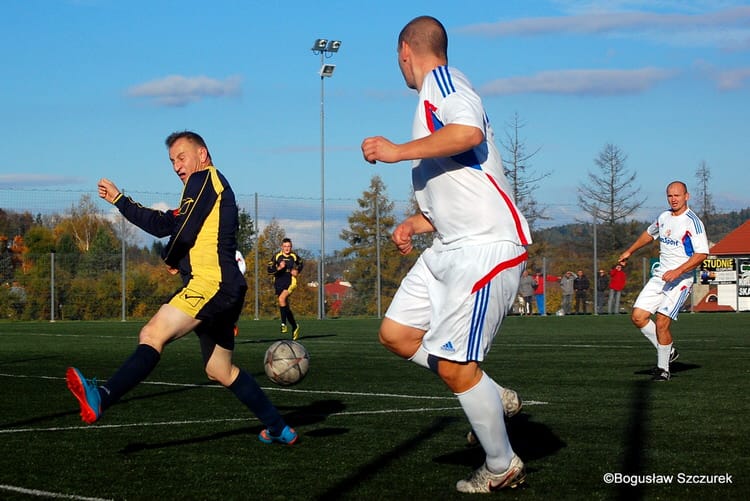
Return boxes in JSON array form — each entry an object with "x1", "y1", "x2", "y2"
[{"x1": 480, "y1": 68, "x2": 675, "y2": 96}]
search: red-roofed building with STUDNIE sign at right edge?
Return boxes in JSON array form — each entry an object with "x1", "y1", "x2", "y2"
[{"x1": 693, "y1": 220, "x2": 750, "y2": 311}]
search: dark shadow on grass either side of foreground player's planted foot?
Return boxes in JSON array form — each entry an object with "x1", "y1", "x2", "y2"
[{"x1": 435, "y1": 413, "x2": 567, "y2": 468}]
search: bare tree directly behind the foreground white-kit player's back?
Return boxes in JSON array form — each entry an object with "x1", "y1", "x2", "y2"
[{"x1": 500, "y1": 112, "x2": 550, "y2": 228}]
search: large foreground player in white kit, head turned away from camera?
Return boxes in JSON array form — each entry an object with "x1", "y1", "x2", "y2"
[{"x1": 362, "y1": 16, "x2": 531, "y2": 492}]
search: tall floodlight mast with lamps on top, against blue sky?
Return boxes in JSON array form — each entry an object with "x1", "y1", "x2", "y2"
[{"x1": 312, "y1": 38, "x2": 341, "y2": 319}]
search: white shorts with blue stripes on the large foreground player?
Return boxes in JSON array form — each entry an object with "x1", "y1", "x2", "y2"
[{"x1": 385, "y1": 242, "x2": 528, "y2": 362}]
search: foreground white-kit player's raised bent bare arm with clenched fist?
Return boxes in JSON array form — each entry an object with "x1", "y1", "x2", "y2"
[{"x1": 362, "y1": 124, "x2": 484, "y2": 164}]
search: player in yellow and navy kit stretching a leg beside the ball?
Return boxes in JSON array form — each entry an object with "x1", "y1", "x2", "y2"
[{"x1": 65, "y1": 131, "x2": 297, "y2": 444}]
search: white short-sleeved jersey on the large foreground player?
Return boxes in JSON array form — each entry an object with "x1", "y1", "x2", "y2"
[{"x1": 412, "y1": 66, "x2": 531, "y2": 247}]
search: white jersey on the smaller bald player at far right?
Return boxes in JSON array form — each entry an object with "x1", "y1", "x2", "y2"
[{"x1": 646, "y1": 209, "x2": 708, "y2": 277}]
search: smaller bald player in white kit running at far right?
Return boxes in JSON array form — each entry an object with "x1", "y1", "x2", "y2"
[{"x1": 620, "y1": 181, "x2": 708, "y2": 381}]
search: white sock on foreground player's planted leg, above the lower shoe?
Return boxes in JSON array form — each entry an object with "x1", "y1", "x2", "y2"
[{"x1": 456, "y1": 374, "x2": 513, "y2": 473}]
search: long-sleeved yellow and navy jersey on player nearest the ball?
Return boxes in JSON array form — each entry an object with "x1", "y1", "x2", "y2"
[{"x1": 114, "y1": 166, "x2": 247, "y2": 292}]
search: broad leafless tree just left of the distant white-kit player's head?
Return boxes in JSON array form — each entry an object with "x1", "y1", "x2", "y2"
[{"x1": 578, "y1": 143, "x2": 646, "y2": 249}]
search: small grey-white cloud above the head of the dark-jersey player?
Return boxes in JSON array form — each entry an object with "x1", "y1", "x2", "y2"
[{"x1": 126, "y1": 75, "x2": 242, "y2": 106}]
